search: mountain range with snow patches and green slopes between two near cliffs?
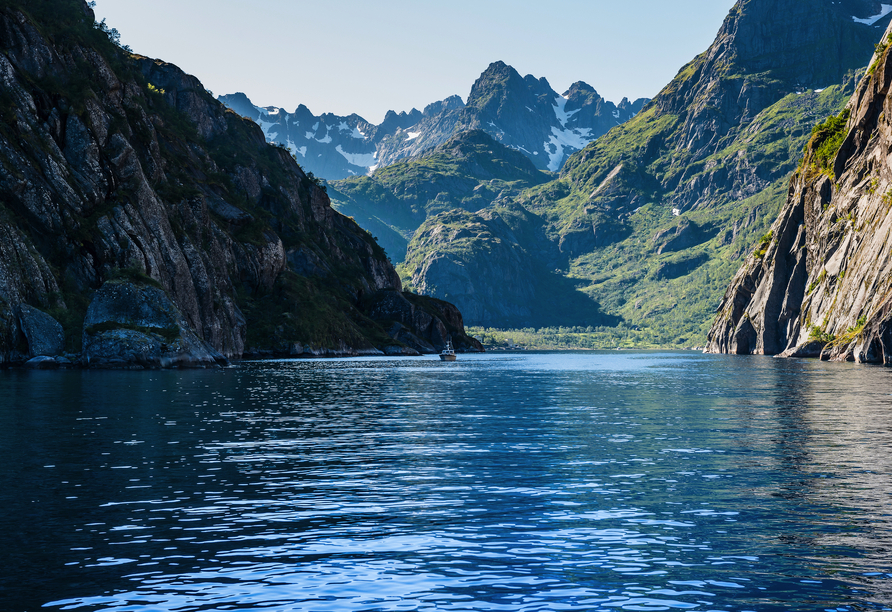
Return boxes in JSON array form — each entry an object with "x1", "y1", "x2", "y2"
[{"x1": 221, "y1": 0, "x2": 890, "y2": 348}]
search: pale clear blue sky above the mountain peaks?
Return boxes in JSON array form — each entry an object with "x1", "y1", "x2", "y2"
[{"x1": 95, "y1": 0, "x2": 734, "y2": 124}]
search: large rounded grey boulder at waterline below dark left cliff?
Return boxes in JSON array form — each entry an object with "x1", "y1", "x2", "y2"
[{"x1": 82, "y1": 281, "x2": 226, "y2": 368}]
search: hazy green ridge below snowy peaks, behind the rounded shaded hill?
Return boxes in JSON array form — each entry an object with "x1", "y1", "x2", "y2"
[{"x1": 329, "y1": 130, "x2": 548, "y2": 262}]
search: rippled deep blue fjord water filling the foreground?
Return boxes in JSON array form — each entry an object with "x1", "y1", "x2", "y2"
[{"x1": 0, "y1": 352, "x2": 892, "y2": 612}]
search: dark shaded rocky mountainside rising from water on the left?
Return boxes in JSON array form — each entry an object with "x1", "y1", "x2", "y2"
[{"x1": 0, "y1": 0, "x2": 480, "y2": 367}]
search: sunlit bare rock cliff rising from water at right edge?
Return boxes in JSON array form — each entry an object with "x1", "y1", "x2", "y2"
[{"x1": 707, "y1": 20, "x2": 892, "y2": 364}]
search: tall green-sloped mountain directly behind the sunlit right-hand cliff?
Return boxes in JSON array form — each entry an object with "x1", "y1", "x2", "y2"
[{"x1": 404, "y1": 0, "x2": 892, "y2": 346}]
